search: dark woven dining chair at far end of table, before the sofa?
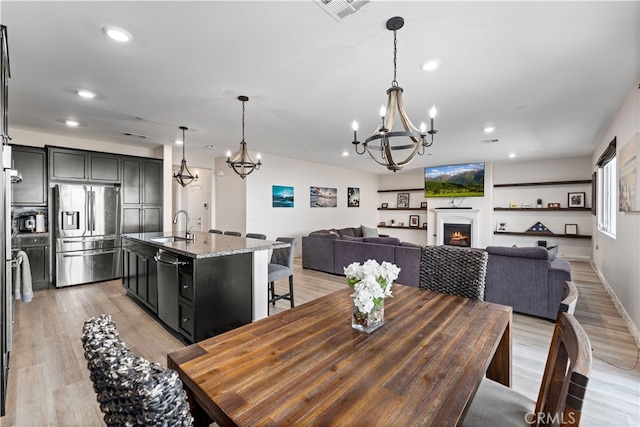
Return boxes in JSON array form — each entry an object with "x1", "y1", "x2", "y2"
[{"x1": 418, "y1": 245, "x2": 489, "y2": 301}]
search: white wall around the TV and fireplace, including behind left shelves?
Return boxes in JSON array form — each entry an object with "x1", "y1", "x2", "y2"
[{"x1": 378, "y1": 163, "x2": 493, "y2": 248}]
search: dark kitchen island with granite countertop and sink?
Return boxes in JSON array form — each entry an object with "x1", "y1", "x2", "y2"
[{"x1": 122, "y1": 232, "x2": 289, "y2": 342}]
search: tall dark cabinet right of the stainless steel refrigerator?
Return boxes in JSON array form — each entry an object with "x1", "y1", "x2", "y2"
[{"x1": 122, "y1": 158, "x2": 163, "y2": 233}]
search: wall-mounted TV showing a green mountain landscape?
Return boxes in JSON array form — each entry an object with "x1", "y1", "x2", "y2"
[{"x1": 424, "y1": 163, "x2": 484, "y2": 198}]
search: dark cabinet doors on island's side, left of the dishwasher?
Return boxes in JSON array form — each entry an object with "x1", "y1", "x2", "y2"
[{"x1": 122, "y1": 240, "x2": 158, "y2": 314}]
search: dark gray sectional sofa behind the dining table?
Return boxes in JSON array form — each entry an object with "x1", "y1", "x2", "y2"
[{"x1": 302, "y1": 227, "x2": 571, "y2": 320}]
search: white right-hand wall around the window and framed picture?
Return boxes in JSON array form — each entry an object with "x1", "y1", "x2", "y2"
[{"x1": 591, "y1": 83, "x2": 640, "y2": 346}]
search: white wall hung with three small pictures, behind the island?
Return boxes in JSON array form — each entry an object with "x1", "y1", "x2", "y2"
[{"x1": 221, "y1": 154, "x2": 378, "y2": 255}]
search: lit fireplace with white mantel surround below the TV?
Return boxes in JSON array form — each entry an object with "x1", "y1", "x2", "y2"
[{"x1": 435, "y1": 208, "x2": 480, "y2": 248}]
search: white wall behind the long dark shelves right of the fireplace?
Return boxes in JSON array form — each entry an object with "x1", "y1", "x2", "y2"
[{"x1": 493, "y1": 156, "x2": 593, "y2": 261}]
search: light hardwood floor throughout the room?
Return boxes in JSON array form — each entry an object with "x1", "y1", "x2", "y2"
[{"x1": 0, "y1": 259, "x2": 640, "y2": 426}]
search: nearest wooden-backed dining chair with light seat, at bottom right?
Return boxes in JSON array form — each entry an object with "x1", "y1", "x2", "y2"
[{"x1": 462, "y1": 310, "x2": 591, "y2": 426}]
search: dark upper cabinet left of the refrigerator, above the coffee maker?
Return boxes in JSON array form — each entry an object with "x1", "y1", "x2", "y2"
[{"x1": 11, "y1": 145, "x2": 47, "y2": 206}]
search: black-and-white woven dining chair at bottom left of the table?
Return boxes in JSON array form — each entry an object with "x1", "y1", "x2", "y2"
[{"x1": 81, "y1": 315, "x2": 193, "y2": 426}]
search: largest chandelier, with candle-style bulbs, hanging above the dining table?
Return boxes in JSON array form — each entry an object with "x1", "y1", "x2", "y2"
[{"x1": 352, "y1": 16, "x2": 438, "y2": 172}]
